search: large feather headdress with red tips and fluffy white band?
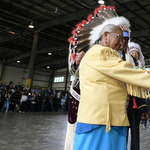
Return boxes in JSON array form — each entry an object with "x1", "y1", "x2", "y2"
[{"x1": 68, "y1": 5, "x2": 130, "y2": 74}]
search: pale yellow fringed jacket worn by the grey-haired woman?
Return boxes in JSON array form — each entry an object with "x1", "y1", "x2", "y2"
[{"x1": 77, "y1": 45, "x2": 150, "y2": 132}]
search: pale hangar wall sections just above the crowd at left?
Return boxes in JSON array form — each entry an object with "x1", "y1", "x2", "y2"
[{"x1": 0, "y1": 65, "x2": 71, "y2": 91}]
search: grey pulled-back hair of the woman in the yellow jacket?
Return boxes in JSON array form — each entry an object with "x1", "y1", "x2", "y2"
[{"x1": 94, "y1": 24, "x2": 120, "y2": 44}]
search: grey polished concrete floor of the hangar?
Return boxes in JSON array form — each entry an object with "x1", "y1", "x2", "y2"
[{"x1": 0, "y1": 112, "x2": 150, "y2": 150}]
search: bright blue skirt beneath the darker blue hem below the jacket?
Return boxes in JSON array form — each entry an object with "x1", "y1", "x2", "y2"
[{"x1": 73, "y1": 125, "x2": 127, "y2": 150}]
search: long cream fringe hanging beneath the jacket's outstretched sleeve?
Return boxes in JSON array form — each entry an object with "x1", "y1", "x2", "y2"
[{"x1": 126, "y1": 83, "x2": 149, "y2": 99}]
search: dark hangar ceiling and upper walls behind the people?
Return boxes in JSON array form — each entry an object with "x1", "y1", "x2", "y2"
[{"x1": 0, "y1": 0, "x2": 150, "y2": 90}]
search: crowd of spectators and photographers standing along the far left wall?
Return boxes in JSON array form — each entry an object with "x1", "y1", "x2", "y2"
[{"x1": 0, "y1": 81, "x2": 68, "y2": 113}]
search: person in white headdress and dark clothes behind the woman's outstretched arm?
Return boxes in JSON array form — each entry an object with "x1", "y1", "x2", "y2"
[{"x1": 127, "y1": 42, "x2": 148, "y2": 150}]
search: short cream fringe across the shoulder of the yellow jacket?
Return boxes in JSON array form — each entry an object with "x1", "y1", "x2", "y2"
[{"x1": 100, "y1": 47, "x2": 120, "y2": 60}]
